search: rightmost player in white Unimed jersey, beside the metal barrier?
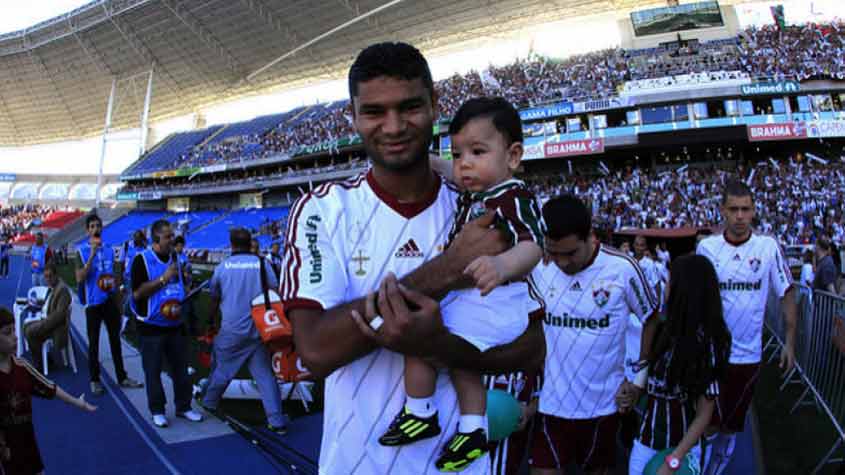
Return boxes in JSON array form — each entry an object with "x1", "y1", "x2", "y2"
[{"x1": 697, "y1": 181, "x2": 797, "y2": 474}]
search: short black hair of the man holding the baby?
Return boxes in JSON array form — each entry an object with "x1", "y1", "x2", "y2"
[{"x1": 349, "y1": 42, "x2": 434, "y2": 99}]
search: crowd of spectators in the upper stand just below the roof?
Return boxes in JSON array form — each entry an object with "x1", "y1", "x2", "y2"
[{"x1": 130, "y1": 22, "x2": 845, "y2": 176}]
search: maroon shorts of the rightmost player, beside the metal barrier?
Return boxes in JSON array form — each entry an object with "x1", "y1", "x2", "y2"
[{"x1": 710, "y1": 363, "x2": 760, "y2": 432}]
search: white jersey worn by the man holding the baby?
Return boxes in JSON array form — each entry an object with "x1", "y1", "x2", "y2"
[{"x1": 281, "y1": 174, "x2": 498, "y2": 475}]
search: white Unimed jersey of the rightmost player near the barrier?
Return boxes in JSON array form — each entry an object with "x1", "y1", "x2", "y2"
[{"x1": 696, "y1": 234, "x2": 792, "y2": 364}]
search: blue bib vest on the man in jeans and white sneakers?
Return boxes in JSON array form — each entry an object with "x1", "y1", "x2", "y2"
[{"x1": 130, "y1": 249, "x2": 185, "y2": 327}]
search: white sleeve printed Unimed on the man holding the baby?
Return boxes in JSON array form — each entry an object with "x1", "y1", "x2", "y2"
[{"x1": 281, "y1": 194, "x2": 348, "y2": 309}]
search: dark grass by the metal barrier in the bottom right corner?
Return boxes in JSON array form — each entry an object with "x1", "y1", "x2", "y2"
[{"x1": 754, "y1": 340, "x2": 845, "y2": 475}]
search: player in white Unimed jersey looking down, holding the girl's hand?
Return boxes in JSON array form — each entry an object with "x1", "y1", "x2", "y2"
[{"x1": 531, "y1": 196, "x2": 658, "y2": 475}]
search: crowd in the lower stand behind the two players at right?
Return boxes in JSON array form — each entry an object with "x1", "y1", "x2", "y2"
[{"x1": 527, "y1": 154, "x2": 845, "y2": 245}]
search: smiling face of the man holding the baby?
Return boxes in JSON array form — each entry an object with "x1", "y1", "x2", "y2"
[{"x1": 352, "y1": 76, "x2": 435, "y2": 171}]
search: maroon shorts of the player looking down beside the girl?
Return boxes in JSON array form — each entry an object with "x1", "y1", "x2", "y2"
[{"x1": 531, "y1": 413, "x2": 619, "y2": 471}]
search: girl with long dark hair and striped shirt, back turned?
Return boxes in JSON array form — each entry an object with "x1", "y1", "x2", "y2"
[{"x1": 629, "y1": 255, "x2": 731, "y2": 475}]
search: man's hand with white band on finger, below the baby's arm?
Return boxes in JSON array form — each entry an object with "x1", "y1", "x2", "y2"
[{"x1": 351, "y1": 273, "x2": 446, "y2": 356}]
